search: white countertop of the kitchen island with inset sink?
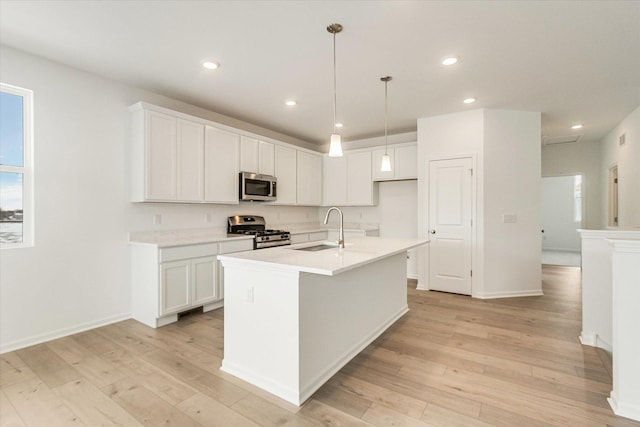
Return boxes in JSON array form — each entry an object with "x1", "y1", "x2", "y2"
[{"x1": 218, "y1": 237, "x2": 429, "y2": 276}]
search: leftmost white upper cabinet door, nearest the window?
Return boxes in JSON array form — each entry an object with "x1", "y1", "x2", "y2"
[{"x1": 145, "y1": 111, "x2": 176, "y2": 200}]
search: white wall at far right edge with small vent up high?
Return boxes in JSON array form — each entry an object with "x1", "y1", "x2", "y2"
[{"x1": 600, "y1": 106, "x2": 640, "y2": 228}]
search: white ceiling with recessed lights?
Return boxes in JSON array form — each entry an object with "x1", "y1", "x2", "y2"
[{"x1": 0, "y1": 0, "x2": 640, "y2": 144}]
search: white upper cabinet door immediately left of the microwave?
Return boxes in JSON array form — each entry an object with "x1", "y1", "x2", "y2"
[{"x1": 204, "y1": 126, "x2": 240, "y2": 204}]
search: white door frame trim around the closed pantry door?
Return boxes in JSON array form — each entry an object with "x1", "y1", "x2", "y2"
[{"x1": 419, "y1": 152, "x2": 476, "y2": 297}]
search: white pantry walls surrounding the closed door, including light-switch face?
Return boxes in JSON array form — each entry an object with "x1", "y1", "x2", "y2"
[{"x1": 418, "y1": 110, "x2": 541, "y2": 298}]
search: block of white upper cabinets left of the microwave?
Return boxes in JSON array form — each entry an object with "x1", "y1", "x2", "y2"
[{"x1": 131, "y1": 103, "x2": 240, "y2": 204}]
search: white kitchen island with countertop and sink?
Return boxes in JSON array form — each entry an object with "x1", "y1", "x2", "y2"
[{"x1": 218, "y1": 237, "x2": 428, "y2": 405}]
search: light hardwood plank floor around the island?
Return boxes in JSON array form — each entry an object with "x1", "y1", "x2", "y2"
[{"x1": 0, "y1": 266, "x2": 640, "y2": 427}]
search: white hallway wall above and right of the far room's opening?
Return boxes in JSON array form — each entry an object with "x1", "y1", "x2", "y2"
[{"x1": 542, "y1": 142, "x2": 602, "y2": 229}]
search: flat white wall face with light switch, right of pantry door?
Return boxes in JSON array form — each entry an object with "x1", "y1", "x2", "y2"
[{"x1": 484, "y1": 110, "x2": 542, "y2": 297}]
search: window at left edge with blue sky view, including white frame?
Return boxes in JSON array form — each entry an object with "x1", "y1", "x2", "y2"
[{"x1": 0, "y1": 83, "x2": 33, "y2": 248}]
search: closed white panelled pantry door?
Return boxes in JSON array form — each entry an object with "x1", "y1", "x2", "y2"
[{"x1": 429, "y1": 157, "x2": 473, "y2": 295}]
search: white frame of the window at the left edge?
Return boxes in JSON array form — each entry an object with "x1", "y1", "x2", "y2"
[{"x1": 0, "y1": 82, "x2": 35, "y2": 249}]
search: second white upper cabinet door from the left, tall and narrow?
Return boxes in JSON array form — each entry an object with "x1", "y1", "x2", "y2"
[{"x1": 176, "y1": 119, "x2": 204, "y2": 202}]
